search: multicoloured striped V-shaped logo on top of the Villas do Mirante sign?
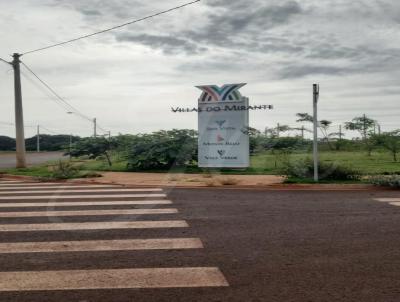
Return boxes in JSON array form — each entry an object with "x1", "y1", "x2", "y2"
[{"x1": 196, "y1": 83, "x2": 246, "y2": 103}]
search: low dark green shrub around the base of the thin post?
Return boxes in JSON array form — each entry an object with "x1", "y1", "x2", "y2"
[{"x1": 282, "y1": 159, "x2": 362, "y2": 181}]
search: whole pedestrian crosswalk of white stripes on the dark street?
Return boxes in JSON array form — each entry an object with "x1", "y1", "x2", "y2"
[{"x1": 0, "y1": 179, "x2": 229, "y2": 292}]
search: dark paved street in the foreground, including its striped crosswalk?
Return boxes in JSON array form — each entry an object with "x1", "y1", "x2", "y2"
[{"x1": 0, "y1": 180, "x2": 400, "y2": 302}]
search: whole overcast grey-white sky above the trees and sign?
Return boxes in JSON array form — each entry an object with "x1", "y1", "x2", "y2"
[{"x1": 0, "y1": 0, "x2": 400, "y2": 136}]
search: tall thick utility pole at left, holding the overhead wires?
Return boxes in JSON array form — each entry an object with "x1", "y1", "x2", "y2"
[{"x1": 12, "y1": 53, "x2": 26, "y2": 168}]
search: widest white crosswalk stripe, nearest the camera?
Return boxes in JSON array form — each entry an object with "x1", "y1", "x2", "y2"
[{"x1": 0, "y1": 267, "x2": 228, "y2": 291}]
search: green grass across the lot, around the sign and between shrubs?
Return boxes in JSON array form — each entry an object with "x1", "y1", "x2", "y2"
[{"x1": 2, "y1": 151, "x2": 400, "y2": 186}]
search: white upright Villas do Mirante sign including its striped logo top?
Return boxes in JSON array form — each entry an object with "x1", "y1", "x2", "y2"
[{"x1": 198, "y1": 84, "x2": 250, "y2": 168}]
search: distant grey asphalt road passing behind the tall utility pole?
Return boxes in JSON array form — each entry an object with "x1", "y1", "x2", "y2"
[{"x1": 0, "y1": 152, "x2": 63, "y2": 169}]
